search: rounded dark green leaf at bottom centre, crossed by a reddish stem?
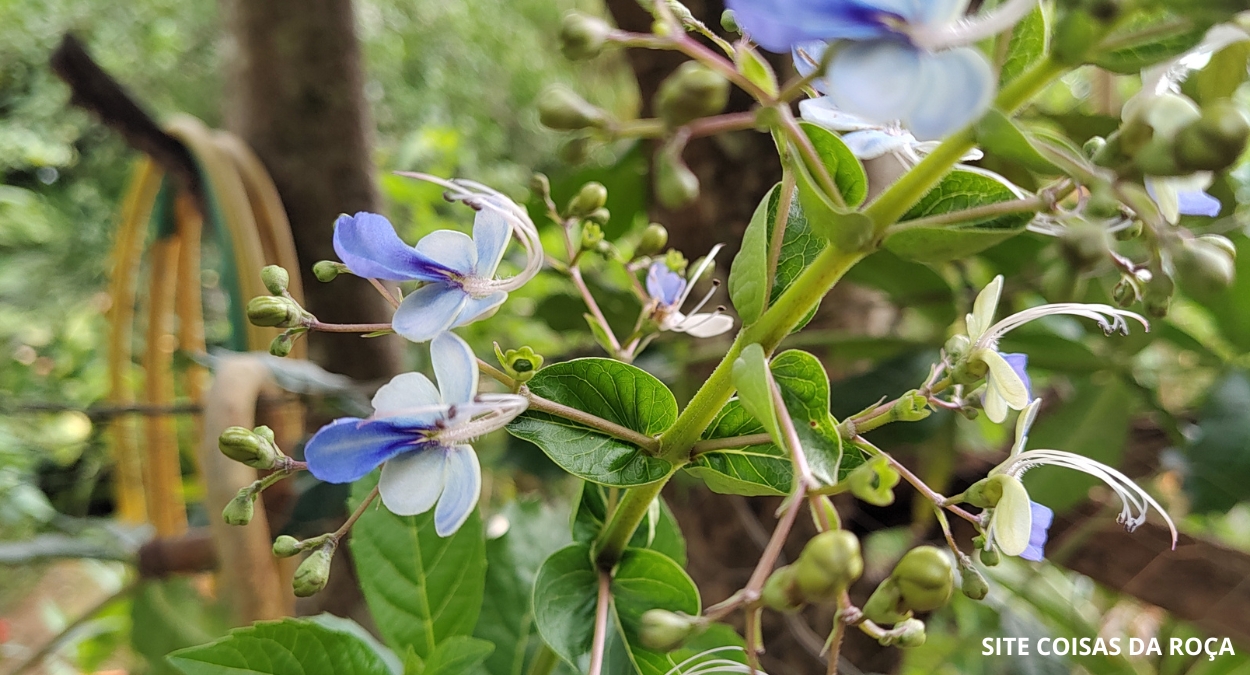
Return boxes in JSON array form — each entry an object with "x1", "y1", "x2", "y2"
[{"x1": 534, "y1": 544, "x2": 700, "y2": 675}]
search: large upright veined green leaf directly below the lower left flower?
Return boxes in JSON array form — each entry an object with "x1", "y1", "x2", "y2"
[{"x1": 348, "y1": 473, "x2": 486, "y2": 659}]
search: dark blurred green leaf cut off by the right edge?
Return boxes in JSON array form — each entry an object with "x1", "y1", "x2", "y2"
[{"x1": 1185, "y1": 370, "x2": 1250, "y2": 514}]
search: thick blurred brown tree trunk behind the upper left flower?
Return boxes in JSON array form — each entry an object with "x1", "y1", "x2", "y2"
[{"x1": 221, "y1": 0, "x2": 403, "y2": 380}]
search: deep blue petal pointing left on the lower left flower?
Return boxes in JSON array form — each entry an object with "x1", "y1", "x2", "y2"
[{"x1": 304, "y1": 418, "x2": 421, "y2": 483}]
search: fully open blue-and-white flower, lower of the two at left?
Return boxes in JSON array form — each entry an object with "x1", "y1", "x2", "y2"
[{"x1": 304, "y1": 333, "x2": 529, "y2": 536}]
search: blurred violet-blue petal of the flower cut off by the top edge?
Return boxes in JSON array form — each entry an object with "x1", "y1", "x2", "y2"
[{"x1": 726, "y1": 0, "x2": 903, "y2": 54}]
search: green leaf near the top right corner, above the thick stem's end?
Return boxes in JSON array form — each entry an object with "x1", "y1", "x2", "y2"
[{"x1": 1091, "y1": 10, "x2": 1210, "y2": 75}]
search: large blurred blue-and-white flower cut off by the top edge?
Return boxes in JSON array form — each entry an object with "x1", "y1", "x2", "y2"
[{"x1": 729, "y1": 0, "x2": 1036, "y2": 140}]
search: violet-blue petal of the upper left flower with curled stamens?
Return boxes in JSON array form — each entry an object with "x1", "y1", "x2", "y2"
[{"x1": 334, "y1": 211, "x2": 462, "y2": 281}]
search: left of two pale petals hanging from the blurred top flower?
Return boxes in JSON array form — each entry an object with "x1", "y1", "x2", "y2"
[{"x1": 825, "y1": 40, "x2": 924, "y2": 126}]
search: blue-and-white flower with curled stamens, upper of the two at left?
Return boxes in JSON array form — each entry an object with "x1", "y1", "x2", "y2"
[{"x1": 334, "y1": 183, "x2": 543, "y2": 343}]
